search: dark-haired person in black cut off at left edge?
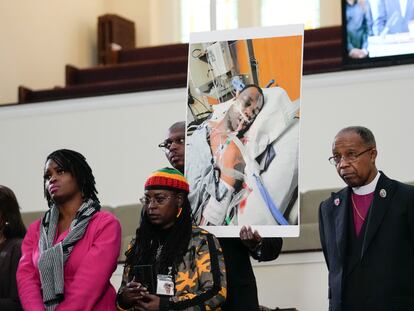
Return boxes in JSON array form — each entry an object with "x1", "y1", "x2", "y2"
[{"x1": 0, "y1": 185, "x2": 26, "y2": 311}]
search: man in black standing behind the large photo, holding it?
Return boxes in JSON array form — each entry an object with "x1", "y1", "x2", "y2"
[{"x1": 159, "y1": 121, "x2": 283, "y2": 311}]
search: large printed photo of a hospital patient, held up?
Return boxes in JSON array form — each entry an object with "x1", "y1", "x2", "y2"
[{"x1": 185, "y1": 25, "x2": 303, "y2": 236}]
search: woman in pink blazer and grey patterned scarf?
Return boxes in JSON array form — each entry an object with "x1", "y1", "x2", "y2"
[{"x1": 17, "y1": 149, "x2": 121, "y2": 311}]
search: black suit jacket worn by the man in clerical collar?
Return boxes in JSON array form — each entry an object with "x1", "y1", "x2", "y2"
[{"x1": 319, "y1": 172, "x2": 414, "y2": 311}]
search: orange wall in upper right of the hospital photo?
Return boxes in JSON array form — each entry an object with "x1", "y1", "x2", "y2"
[{"x1": 252, "y1": 36, "x2": 302, "y2": 101}]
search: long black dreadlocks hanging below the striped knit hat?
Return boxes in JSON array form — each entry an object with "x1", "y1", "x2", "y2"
[{"x1": 125, "y1": 191, "x2": 192, "y2": 273}]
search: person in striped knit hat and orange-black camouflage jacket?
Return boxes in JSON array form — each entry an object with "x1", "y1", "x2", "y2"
[{"x1": 117, "y1": 168, "x2": 226, "y2": 311}]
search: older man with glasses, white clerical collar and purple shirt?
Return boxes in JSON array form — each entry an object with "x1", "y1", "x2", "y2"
[{"x1": 319, "y1": 126, "x2": 414, "y2": 311}]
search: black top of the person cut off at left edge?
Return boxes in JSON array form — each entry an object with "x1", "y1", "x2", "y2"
[{"x1": 0, "y1": 239, "x2": 22, "y2": 311}]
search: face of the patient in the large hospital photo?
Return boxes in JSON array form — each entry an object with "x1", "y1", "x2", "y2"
[{"x1": 229, "y1": 87, "x2": 263, "y2": 132}]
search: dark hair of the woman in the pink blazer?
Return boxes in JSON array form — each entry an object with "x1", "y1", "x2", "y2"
[{"x1": 43, "y1": 149, "x2": 99, "y2": 206}]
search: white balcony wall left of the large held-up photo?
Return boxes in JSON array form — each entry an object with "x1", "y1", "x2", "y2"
[{"x1": 0, "y1": 89, "x2": 186, "y2": 211}]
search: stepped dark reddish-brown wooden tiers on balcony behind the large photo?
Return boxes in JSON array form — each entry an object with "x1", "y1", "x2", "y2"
[{"x1": 14, "y1": 26, "x2": 343, "y2": 103}]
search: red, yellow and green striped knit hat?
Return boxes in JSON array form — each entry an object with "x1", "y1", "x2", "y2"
[{"x1": 144, "y1": 167, "x2": 190, "y2": 193}]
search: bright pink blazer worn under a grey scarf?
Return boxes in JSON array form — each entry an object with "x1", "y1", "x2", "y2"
[{"x1": 16, "y1": 211, "x2": 121, "y2": 311}]
